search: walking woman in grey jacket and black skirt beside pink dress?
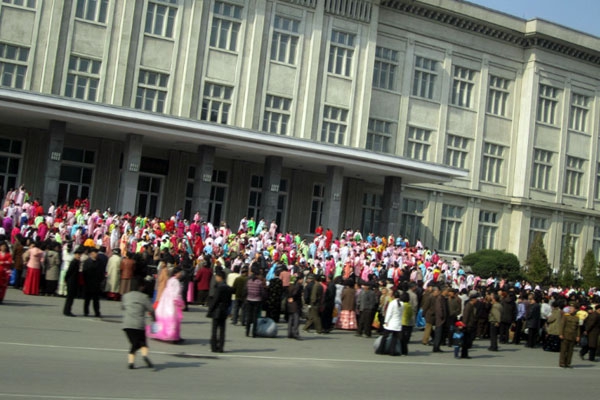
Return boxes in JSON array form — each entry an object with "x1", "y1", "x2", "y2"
[{"x1": 121, "y1": 279, "x2": 154, "y2": 369}]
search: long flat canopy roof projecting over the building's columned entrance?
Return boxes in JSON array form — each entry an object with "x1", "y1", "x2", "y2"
[{"x1": 0, "y1": 89, "x2": 468, "y2": 184}]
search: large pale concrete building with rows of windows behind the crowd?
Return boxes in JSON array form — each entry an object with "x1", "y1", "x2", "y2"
[{"x1": 0, "y1": 0, "x2": 600, "y2": 268}]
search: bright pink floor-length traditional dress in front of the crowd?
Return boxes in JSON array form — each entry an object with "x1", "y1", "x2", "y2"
[{"x1": 146, "y1": 277, "x2": 185, "y2": 342}]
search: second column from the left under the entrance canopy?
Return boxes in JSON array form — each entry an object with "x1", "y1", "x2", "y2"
[{"x1": 118, "y1": 134, "x2": 144, "y2": 213}]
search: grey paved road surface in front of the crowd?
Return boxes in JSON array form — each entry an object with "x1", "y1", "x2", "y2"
[{"x1": 0, "y1": 289, "x2": 600, "y2": 400}]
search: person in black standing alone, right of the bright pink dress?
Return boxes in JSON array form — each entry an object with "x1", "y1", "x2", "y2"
[{"x1": 208, "y1": 271, "x2": 231, "y2": 353}]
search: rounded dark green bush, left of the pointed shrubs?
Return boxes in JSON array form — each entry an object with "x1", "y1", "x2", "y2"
[{"x1": 463, "y1": 249, "x2": 521, "y2": 280}]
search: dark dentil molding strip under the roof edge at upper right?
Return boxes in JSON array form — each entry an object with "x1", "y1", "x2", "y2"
[{"x1": 381, "y1": 0, "x2": 600, "y2": 65}]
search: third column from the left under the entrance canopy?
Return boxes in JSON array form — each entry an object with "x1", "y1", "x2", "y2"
[{"x1": 192, "y1": 146, "x2": 220, "y2": 220}]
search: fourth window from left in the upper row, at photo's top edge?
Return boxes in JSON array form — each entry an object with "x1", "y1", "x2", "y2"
[{"x1": 210, "y1": 1, "x2": 242, "y2": 51}]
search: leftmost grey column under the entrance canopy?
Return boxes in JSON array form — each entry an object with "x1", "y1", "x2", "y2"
[{"x1": 42, "y1": 121, "x2": 67, "y2": 208}]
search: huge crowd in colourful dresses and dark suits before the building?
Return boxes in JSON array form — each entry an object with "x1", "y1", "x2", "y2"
[{"x1": 0, "y1": 186, "x2": 600, "y2": 367}]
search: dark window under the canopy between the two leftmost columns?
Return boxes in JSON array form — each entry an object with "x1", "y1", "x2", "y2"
[{"x1": 57, "y1": 147, "x2": 95, "y2": 204}]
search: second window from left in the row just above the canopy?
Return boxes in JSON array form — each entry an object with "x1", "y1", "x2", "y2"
[{"x1": 65, "y1": 56, "x2": 101, "y2": 101}]
